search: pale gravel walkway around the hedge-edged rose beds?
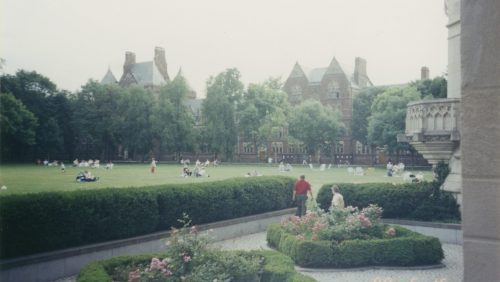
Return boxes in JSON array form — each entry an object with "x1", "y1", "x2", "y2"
[{"x1": 216, "y1": 232, "x2": 464, "y2": 282}]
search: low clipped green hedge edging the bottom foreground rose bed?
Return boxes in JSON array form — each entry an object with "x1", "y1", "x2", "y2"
[{"x1": 76, "y1": 250, "x2": 316, "y2": 282}]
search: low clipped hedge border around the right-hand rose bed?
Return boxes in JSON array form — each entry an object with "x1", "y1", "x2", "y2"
[{"x1": 267, "y1": 224, "x2": 444, "y2": 268}]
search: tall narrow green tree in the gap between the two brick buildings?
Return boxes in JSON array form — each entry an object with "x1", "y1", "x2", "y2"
[{"x1": 202, "y1": 69, "x2": 243, "y2": 159}]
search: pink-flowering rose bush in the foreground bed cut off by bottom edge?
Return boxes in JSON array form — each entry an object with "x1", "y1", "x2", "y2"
[{"x1": 127, "y1": 214, "x2": 261, "y2": 282}]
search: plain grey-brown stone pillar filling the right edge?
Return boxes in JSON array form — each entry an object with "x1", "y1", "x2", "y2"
[{"x1": 461, "y1": 0, "x2": 500, "y2": 282}]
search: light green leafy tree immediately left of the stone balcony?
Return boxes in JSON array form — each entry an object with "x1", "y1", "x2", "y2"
[{"x1": 368, "y1": 85, "x2": 420, "y2": 153}]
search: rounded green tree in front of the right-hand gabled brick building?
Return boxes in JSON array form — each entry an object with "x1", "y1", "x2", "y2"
[{"x1": 289, "y1": 100, "x2": 344, "y2": 154}]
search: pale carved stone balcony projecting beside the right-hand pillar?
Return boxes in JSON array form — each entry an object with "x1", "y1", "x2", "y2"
[{"x1": 398, "y1": 98, "x2": 460, "y2": 164}]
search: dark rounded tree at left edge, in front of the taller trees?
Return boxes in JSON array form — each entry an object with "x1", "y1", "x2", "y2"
[{"x1": 0, "y1": 93, "x2": 37, "y2": 161}]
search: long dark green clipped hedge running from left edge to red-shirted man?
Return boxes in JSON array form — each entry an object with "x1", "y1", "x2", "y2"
[{"x1": 0, "y1": 177, "x2": 295, "y2": 258}]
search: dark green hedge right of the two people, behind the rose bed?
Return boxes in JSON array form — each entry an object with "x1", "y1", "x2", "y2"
[{"x1": 316, "y1": 182, "x2": 460, "y2": 221}]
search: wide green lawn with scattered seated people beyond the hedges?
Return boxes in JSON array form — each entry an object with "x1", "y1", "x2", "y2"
[{"x1": 0, "y1": 164, "x2": 433, "y2": 195}]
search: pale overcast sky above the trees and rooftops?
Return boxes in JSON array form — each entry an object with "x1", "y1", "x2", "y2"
[{"x1": 0, "y1": 0, "x2": 447, "y2": 96}]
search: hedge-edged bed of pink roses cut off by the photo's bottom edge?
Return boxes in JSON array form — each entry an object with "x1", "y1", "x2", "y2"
[{"x1": 77, "y1": 215, "x2": 315, "y2": 282}]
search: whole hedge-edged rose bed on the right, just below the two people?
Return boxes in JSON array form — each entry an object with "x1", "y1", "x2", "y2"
[{"x1": 267, "y1": 205, "x2": 444, "y2": 268}]
